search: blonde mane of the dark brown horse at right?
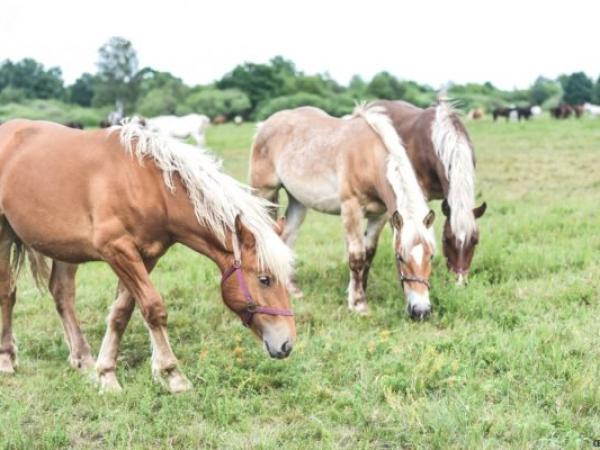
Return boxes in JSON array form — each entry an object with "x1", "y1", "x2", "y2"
[{"x1": 431, "y1": 98, "x2": 477, "y2": 244}]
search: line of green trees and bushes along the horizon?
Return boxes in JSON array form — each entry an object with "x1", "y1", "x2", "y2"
[{"x1": 0, "y1": 37, "x2": 600, "y2": 120}]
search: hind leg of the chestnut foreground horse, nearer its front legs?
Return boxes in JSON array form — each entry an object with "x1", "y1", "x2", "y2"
[{"x1": 49, "y1": 261, "x2": 94, "y2": 371}]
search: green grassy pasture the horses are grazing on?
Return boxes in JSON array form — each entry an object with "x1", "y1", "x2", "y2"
[{"x1": 0, "y1": 118, "x2": 600, "y2": 450}]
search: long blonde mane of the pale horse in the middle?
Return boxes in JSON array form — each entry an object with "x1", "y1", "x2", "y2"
[{"x1": 353, "y1": 104, "x2": 435, "y2": 256}]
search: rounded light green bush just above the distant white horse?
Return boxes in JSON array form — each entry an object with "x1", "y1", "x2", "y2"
[{"x1": 185, "y1": 88, "x2": 251, "y2": 119}]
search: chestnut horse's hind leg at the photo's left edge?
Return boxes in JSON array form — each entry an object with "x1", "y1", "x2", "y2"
[{"x1": 0, "y1": 217, "x2": 17, "y2": 373}]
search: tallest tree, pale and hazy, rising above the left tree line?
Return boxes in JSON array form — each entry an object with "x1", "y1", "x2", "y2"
[{"x1": 93, "y1": 37, "x2": 138, "y2": 111}]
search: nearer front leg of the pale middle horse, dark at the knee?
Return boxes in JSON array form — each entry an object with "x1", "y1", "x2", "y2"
[{"x1": 342, "y1": 198, "x2": 369, "y2": 314}]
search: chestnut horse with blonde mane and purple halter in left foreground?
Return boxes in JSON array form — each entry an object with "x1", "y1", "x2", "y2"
[{"x1": 0, "y1": 120, "x2": 296, "y2": 392}]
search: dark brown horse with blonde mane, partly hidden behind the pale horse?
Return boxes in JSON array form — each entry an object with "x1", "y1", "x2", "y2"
[{"x1": 374, "y1": 100, "x2": 486, "y2": 283}]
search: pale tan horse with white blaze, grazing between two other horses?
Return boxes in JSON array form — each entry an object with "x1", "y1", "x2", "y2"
[{"x1": 250, "y1": 107, "x2": 435, "y2": 319}]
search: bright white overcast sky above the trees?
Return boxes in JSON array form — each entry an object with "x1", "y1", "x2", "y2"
[{"x1": 0, "y1": 0, "x2": 600, "y2": 88}]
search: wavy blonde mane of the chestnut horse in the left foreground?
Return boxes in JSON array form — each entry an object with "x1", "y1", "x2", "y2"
[{"x1": 113, "y1": 118, "x2": 293, "y2": 281}]
